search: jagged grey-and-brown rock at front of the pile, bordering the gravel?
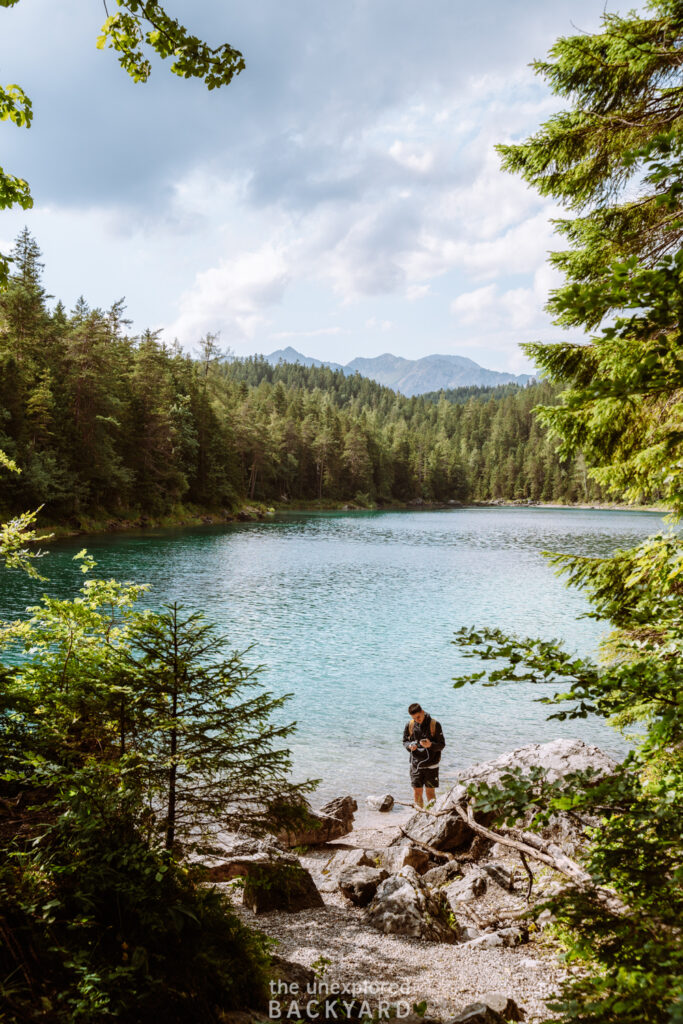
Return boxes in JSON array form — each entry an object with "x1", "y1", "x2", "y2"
[{"x1": 366, "y1": 867, "x2": 458, "y2": 942}]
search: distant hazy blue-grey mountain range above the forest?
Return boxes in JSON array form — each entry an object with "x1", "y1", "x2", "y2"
[{"x1": 265, "y1": 346, "x2": 533, "y2": 397}]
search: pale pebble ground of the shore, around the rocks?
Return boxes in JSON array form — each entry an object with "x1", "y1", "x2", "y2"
[{"x1": 227, "y1": 808, "x2": 567, "y2": 1024}]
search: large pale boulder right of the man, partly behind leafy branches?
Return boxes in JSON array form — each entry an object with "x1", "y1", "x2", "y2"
[{"x1": 391, "y1": 739, "x2": 615, "y2": 850}]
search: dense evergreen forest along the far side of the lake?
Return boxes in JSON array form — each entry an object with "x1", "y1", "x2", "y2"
[{"x1": 0, "y1": 230, "x2": 601, "y2": 521}]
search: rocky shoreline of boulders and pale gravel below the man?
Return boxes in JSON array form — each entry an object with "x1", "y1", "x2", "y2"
[{"x1": 206, "y1": 739, "x2": 614, "y2": 1024}]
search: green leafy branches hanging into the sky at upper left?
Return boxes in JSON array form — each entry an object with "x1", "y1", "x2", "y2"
[{"x1": 0, "y1": 0, "x2": 245, "y2": 289}]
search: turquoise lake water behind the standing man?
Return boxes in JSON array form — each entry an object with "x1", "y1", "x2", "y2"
[{"x1": 0, "y1": 508, "x2": 661, "y2": 803}]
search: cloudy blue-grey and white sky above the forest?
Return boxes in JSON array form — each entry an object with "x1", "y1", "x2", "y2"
[{"x1": 0, "y1": 0, "x2": 618, "y2": 372}]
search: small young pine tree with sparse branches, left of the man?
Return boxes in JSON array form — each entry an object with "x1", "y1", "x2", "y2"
[{"x1": 123, "y1": 604, "x2": 312, "y2": 850}]
